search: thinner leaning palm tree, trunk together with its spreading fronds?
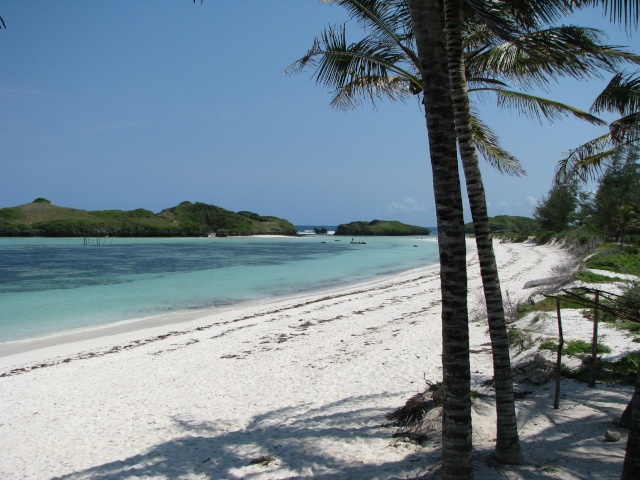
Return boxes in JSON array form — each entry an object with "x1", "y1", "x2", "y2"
[{"x1": 288, "y1": 0, "x2": 640, "y2": 463}]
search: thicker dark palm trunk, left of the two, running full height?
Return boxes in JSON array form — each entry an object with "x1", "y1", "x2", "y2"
[{"x1": 408, "y1": 0, "x2": 473, "y2": 480}]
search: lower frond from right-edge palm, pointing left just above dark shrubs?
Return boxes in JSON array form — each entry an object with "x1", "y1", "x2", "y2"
[{"x1": 556, "y1": 133, "x2": 621, "y2": 182}]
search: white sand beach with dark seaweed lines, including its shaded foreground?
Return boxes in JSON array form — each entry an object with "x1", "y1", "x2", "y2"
[{"x1": 0, "y1": 243, "x2": 631, "y2": 480}]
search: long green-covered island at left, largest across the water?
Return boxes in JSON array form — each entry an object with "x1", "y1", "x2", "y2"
[{"x1": 0, "y1": 198, "x2": 297, "y2": 237}]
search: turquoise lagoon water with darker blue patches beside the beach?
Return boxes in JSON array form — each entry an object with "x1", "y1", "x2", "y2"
[{"x1": 0, "y1": 235, "x2": 438, "y2": 342}]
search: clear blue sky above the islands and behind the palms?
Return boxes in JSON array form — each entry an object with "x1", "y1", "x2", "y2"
[{"x1": 0, "y1": 0, "x2": 638, "y2": 226}]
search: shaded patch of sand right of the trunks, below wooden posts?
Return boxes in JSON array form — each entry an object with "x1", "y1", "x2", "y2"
[{"x1": 468, "y1": 380, "x2": 631, "y2": 480}]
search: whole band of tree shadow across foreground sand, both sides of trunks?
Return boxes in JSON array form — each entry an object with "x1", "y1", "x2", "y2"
[{"x1": 50, "y1": 381, "x2": 628, "y2": 480}]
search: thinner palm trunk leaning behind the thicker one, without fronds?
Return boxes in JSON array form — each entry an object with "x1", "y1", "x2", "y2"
[{"x1": 444, "y1": 0, "x2": 524, "y2": 465}]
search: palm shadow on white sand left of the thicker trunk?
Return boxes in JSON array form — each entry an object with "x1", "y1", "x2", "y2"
[{"x1": 56, "y1": 395, "x2": 439, "y2": 480}]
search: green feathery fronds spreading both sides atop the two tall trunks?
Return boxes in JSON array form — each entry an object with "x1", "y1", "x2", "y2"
[{"x1": 285, "y1": 0, "x2": 640, "y2": 175}]
